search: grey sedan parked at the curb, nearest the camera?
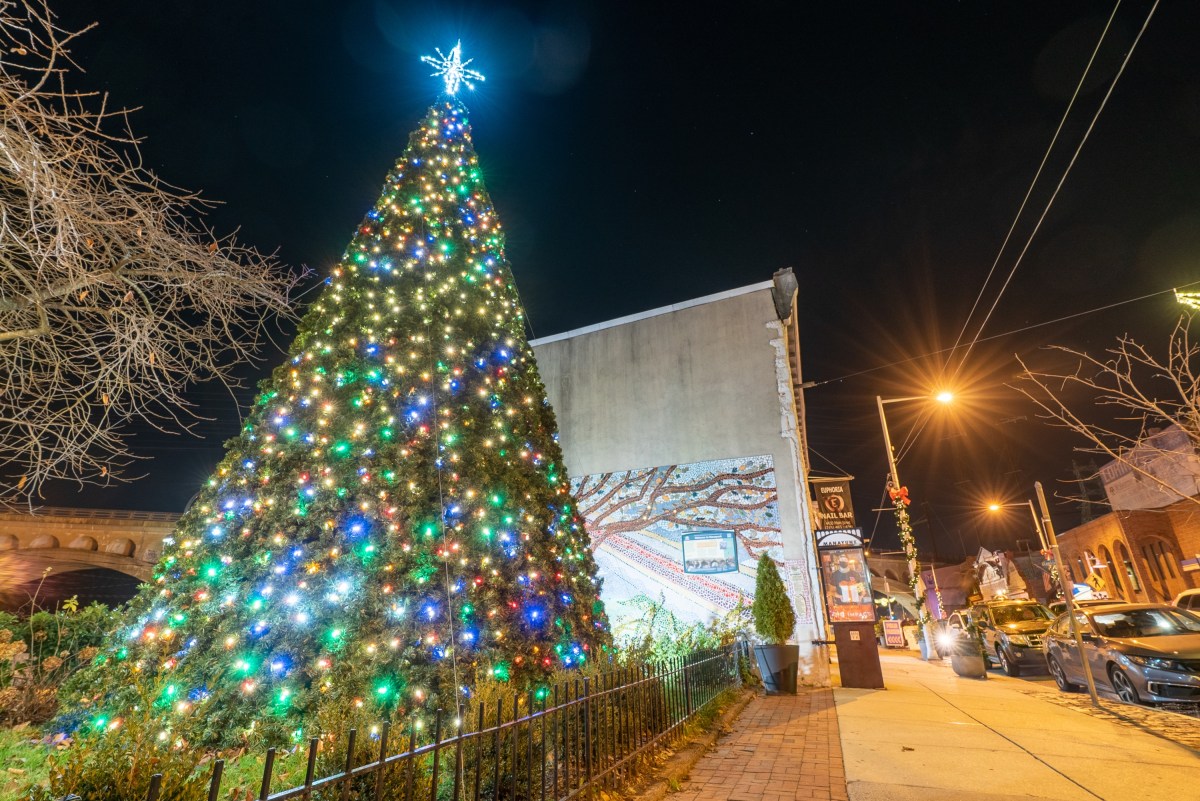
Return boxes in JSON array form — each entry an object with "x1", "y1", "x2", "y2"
[{"x1": 1043, "y1": 603, "x2": 1200, "y2": 704}]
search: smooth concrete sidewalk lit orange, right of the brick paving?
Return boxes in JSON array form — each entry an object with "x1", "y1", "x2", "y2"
[{"x1": 834, "y1": 652, "x2": 1200, "y2": 801}]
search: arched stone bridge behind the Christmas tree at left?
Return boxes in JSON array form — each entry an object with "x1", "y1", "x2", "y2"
[{"x1": 0, "y1": 507, "x2": 179, "y2": 610}]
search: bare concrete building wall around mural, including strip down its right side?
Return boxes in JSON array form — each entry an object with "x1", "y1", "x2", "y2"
[{"x1": 530, "y1": 282, "x2": 824, "y2": 639}]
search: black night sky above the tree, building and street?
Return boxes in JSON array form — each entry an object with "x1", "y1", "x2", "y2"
[{"x1": 39, "y1": 0, "x2": 1200, "y2": 556}]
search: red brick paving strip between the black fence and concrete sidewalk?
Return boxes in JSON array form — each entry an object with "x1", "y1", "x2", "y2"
[{"x1": 668, "y1": 689, "x2": 847, "y2": 801}]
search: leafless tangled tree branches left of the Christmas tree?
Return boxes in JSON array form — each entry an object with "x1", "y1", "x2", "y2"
[{"x1": 0, "y1": 0, "x2": 302, "y2": 499}]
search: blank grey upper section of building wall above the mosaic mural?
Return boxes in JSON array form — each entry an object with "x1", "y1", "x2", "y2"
[{"x1": 532, "y1": 288, "x2": 791, "y2": 475}]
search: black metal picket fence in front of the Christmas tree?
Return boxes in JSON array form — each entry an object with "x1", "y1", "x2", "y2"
[{"x1": 145, "y1": 642, "x2": 752, "y2": 801}]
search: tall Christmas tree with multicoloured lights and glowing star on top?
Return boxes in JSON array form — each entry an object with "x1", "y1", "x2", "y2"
[{"x1": 77, "y1": 47, "x2": 610, "y2": 742}]
